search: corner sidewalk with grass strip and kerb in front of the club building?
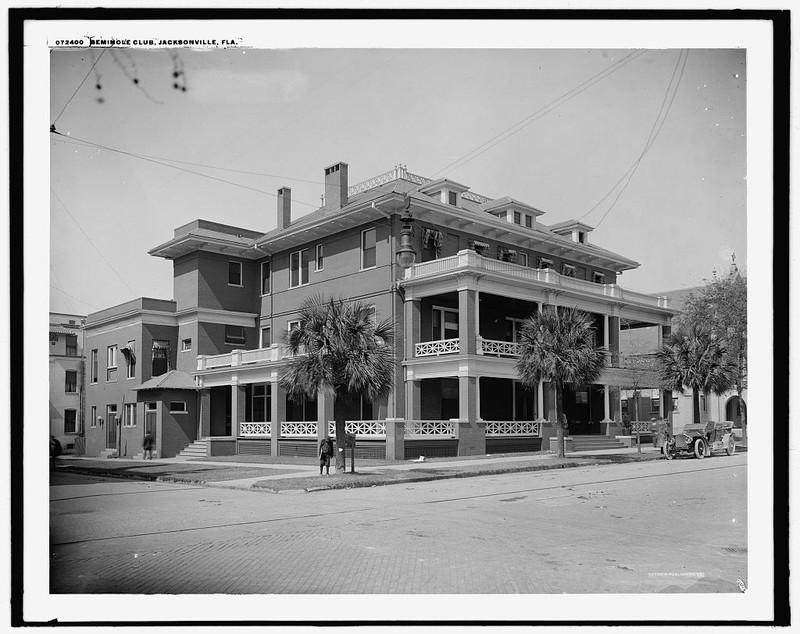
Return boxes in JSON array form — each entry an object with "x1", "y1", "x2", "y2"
[{"x1": 57, "y1": 446, "x2": 662, "y2": 493}]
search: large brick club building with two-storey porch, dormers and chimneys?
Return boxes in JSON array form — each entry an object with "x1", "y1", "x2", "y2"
[{"x1": 86, "y1": 163, "x2": 675, "y2": 459}]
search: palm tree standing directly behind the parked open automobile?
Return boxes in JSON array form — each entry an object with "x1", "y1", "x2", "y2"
[{"x1": 656, "y1": 323, "x2": 736, "y2": 423}]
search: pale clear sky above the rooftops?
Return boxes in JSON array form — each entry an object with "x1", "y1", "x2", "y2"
[{"x1": 50, "y1": 43, "x2": 747, "y2": 314}]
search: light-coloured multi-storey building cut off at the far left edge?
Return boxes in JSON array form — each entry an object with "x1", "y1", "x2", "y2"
[{"x1": 50, "y1": 313, "x2": 86, "y2": 453}]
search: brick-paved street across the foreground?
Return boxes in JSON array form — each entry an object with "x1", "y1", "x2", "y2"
[{"x1": 50, "y1": 454, "x2": 747, "y2": 594}]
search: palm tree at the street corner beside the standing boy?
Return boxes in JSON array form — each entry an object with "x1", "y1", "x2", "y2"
[{"x1": 280, "y1": 296, "x2": 395, "y2": 474}]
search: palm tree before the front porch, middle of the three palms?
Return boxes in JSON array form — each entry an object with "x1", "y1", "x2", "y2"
[{"x1": 517, "y1": 306, "x2": 605, "y2": 458}]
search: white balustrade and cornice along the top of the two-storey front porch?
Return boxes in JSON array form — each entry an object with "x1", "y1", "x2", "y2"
[{"x1": 405, "y1": 250, "x2": 669, "y2": 309}]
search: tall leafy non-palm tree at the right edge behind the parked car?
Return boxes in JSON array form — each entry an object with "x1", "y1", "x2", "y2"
[{"x1": 681, "y1": 264, "x2": 747, "y2": 443}]
